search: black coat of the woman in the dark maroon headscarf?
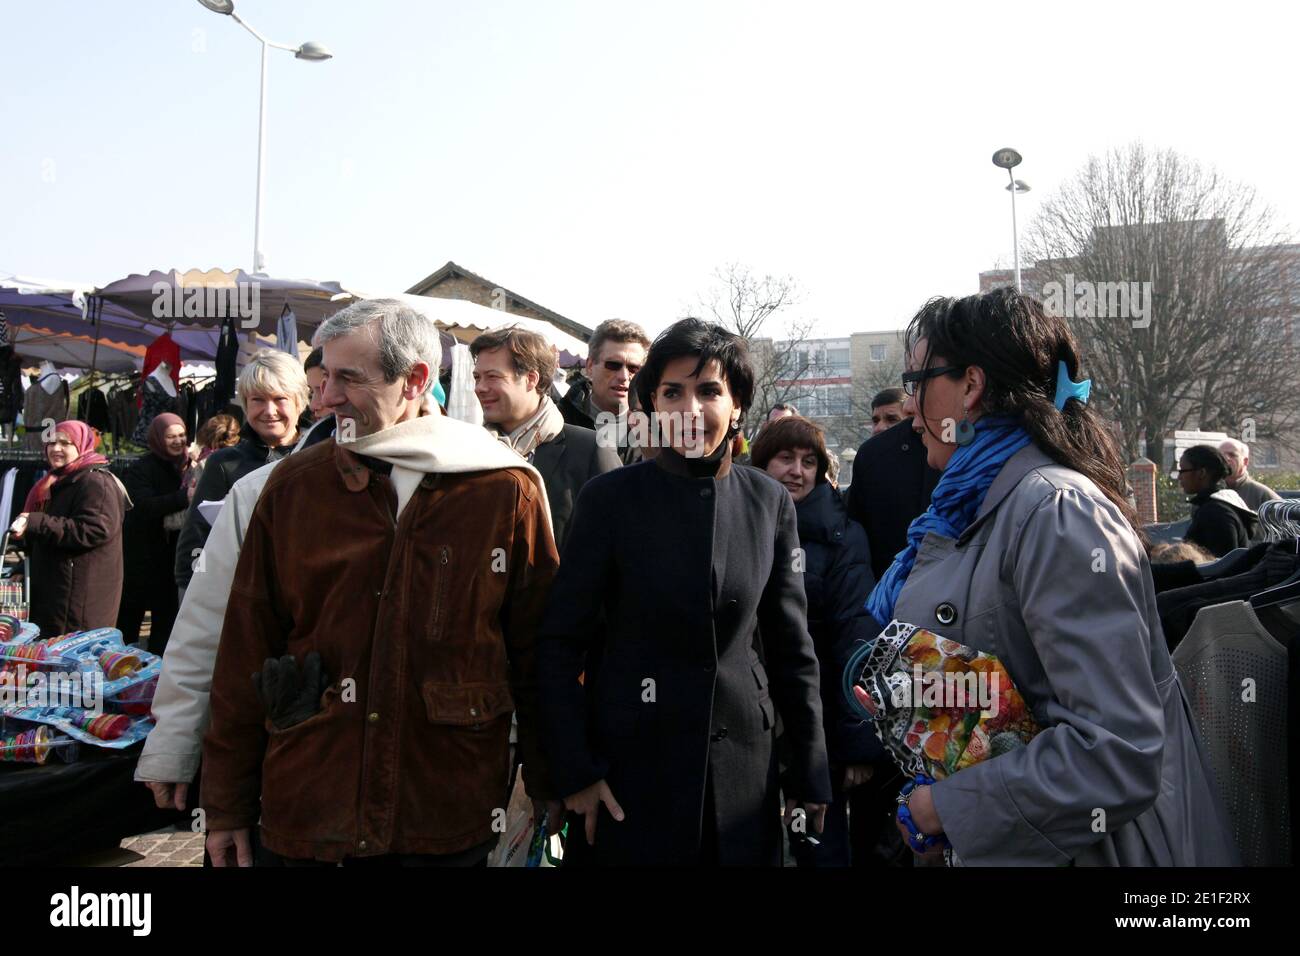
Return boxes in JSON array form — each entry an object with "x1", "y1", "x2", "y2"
[{"x1": 122, "y1": 451, "x2": 190, "y2": 601}]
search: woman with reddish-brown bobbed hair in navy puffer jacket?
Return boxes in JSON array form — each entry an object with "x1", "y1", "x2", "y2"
[{"x1": 750, "y1": 415, "x2": 893, "y2": 866}]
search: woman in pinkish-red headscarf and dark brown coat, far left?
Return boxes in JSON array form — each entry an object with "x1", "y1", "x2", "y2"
[{"x1": 9, "y1": 421, "x2": 131, "y2": 637}]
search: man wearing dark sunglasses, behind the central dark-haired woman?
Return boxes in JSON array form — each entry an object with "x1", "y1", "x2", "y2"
[{"x1": 556, "y1": 319, "x2": 650, "y2": 464}]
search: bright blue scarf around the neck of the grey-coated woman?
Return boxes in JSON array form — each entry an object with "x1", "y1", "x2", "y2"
[{"x1": 866, "y1": 416, "x2": 1030, "y2": 628}]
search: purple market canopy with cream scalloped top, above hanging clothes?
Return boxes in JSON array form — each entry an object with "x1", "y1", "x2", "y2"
[{"x1": 94, "y1": 269, "x2": 347, "y2": 343}]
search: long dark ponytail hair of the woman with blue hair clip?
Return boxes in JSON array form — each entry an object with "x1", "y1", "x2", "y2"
[{"x1": 906, "y1": 287, "x2": 1141, "y2": 537}]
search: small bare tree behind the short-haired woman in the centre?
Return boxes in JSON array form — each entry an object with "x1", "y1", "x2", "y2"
[{"x1": 699, "y1": 263, "x2": 816, "y2": 437}]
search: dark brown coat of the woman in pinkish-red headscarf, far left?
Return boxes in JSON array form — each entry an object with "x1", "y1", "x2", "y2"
[{"x1": 23, "y1": 467, "x2": 126, "y2": 637}]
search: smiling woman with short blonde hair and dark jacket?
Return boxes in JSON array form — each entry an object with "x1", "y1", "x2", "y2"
[{"x1": 176, "y1": 349, "x2": 311, "y2": 592}]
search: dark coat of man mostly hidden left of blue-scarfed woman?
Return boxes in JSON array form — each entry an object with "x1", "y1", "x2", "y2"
[{"x1": 848, "y1": 419, "x2": 940, "y2": 581}]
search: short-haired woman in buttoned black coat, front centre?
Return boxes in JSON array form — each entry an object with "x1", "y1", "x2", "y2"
[{"x1": 538, "y1": 319, "x2": 831, "y2": 865}]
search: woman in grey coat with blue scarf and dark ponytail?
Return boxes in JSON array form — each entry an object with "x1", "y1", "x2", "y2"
[{"x1": 867, "y1": 289, "x2": 1238, "y2": 866}]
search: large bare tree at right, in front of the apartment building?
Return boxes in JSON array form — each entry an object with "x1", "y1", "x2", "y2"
[{"x1": 1026, "y1": 144, "x2": 1300, "y2": 464}]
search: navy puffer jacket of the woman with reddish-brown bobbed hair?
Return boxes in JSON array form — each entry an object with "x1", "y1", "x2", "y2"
[{"x1": 794, "y1": 481, "x2": 885, "y2": 766}]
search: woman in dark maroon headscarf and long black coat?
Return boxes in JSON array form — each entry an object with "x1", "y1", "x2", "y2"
[{"x1": 117, "y1": 412, "x2": 190, "y2": 654}]
